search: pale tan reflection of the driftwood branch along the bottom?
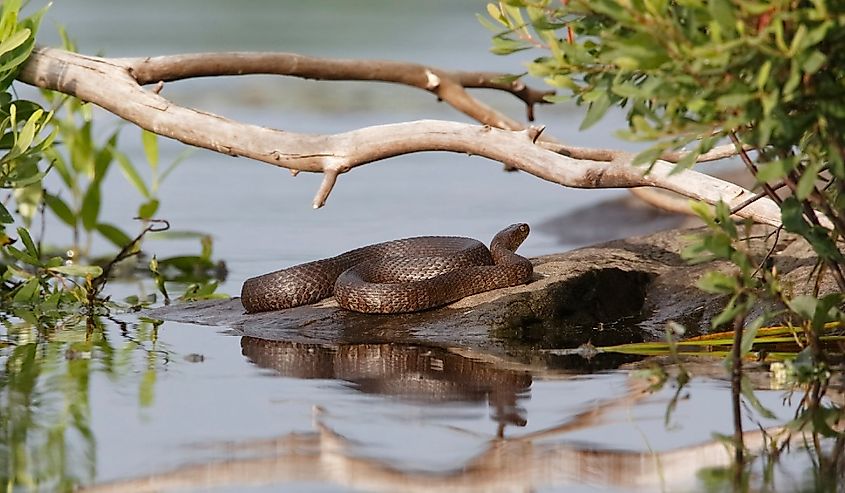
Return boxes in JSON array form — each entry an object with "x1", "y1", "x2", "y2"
[{"x1": 81, "y1": 370, "x2": 842, "y2": 493}]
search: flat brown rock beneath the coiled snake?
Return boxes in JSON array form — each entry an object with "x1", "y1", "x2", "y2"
[{"x1": 146, "y1": 227, "x2": 835, "y2": 371}]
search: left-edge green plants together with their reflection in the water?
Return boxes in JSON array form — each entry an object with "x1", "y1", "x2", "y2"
[{"x1": 0, "y1": 0, "x2": 223, "y2": 491}]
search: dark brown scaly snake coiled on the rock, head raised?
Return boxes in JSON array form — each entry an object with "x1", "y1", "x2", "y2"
[{"x1": 241, "y1": 223, "x2": 534, "y2": 313}]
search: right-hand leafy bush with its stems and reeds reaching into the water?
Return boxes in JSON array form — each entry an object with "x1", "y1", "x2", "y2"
[{"x1": 483, "y1": 0, "x2": 845, "y2": 490}]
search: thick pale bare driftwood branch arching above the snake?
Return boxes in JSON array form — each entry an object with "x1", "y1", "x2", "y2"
[{"x1": 18, "y1": 48, "x2": 780, "y2": 225}]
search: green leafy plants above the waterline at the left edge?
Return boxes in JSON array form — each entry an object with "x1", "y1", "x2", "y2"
[{"x1": 0, "y1": 1, "x2": 225, "y2": 323}]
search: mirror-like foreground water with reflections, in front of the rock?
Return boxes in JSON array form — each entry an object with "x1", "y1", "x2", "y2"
[{"x1": 0, "y1": 317, "x2": 845, "y2": 492}]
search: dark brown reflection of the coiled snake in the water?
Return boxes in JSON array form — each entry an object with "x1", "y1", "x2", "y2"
[{"x1": 241, "y1": 337, "x2": 532, "y2": 428}]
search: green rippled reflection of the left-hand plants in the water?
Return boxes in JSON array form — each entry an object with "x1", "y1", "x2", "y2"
[{"x1": 0, "y1": 313, "x2": 168, "y2": 491}]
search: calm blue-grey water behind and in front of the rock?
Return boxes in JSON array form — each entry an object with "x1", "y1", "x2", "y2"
[{"x1": 0, "y1": 0, "x2": 836, "y2": 492}]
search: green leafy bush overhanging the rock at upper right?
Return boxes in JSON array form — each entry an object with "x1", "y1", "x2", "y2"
[{"x1": 486, "y1": 0, "x2": 845, "y2": 350}]
